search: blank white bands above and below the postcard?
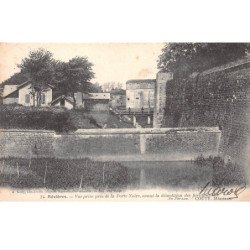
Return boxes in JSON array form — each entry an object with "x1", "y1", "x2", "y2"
[{"x1": 0, "y1": 0, "x2": 250, "y2": 250}]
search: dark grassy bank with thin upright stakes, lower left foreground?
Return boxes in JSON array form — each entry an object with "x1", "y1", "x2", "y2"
[{"x1": 0, "y1": 158, "x2": 128, "y2": 191}]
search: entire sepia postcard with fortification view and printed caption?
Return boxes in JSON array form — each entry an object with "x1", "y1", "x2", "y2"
[{"x1": 0, "y1": 42, "x2": 250, "y2": 201}]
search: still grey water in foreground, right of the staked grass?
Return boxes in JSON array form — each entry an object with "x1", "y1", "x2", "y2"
[{"x1": 122, "y1": 161, "x2": 212, "y2": 189}]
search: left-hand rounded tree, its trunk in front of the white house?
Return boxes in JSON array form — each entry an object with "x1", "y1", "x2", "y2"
[{"x1": 18, "y1": 48, "x2": 55, "y2": 106}]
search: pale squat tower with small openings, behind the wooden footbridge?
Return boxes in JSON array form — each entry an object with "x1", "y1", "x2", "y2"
[{"x1": 126, "y1": 79, "x2": 156, "y2": 111}]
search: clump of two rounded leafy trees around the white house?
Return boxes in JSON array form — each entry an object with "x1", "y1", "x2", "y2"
[{"x1": 3, "y1": 48, "x2": 95, "y2": 107}]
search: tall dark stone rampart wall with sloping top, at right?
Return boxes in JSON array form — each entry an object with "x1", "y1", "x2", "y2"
[{"x1": 164, "y1": 59, "x2": 250, "y2": 165}]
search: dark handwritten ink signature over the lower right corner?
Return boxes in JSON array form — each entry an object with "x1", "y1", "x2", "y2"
[{"x1": 199, "y1": 182, "x2": 246, "y2": 199}]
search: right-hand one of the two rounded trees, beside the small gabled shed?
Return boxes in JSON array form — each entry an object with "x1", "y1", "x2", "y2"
[{"x1": 55, "y1": 57, "x2": 94, "y2": 108}]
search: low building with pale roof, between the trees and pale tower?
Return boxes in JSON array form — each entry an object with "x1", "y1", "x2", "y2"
[{"x1": 74, "y1": 92, "x2": 110, "y2": 111}]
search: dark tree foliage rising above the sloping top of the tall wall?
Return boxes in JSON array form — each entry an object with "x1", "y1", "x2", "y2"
[{"x1": 158, "y1": 43, "x2": 249, "y2": 78}]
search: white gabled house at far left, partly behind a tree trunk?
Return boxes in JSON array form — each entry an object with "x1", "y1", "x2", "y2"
[{"x1": 3, "y1": 80, "x2": 53, "y2": 106}]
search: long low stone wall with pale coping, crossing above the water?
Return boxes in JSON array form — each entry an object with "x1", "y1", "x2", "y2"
[{"x1": 0, "y1": 127, "x2": 221, "y2": 161}]
